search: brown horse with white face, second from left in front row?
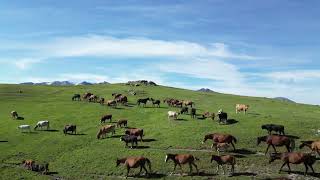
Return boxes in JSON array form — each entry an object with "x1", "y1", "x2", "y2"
[{"x1": 165, "y1": 154, "x2": 199, "y2": 174}]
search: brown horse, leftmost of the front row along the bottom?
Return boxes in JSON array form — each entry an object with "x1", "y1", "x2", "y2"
[{"x1": 116, "y1": 156, "x2": 151, "y2": 177}]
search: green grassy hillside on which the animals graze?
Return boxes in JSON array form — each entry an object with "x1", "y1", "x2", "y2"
[{"x1": 0, "y1": 84, "x2": 320, "y2": 179}]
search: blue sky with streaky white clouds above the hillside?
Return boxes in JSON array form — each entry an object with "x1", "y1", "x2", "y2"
[{"x1": 0, "y1": 0, "x2": 320, "y2": 104}]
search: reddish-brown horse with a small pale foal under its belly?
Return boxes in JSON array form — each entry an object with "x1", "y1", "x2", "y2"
[{"x1": 202, "y1": 133, "x2": 237, "y2": 151}]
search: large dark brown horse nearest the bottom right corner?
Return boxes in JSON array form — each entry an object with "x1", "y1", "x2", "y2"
[{"x1": 269, "y1": 152, "x2": 316, "y2": 175}]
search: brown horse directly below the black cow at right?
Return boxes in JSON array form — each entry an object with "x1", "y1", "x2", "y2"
[{"x1": 257, "y1": 135, "x2": 295, "y2": 154}]
